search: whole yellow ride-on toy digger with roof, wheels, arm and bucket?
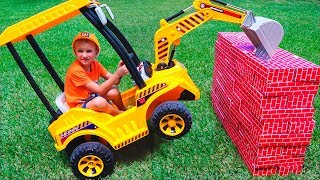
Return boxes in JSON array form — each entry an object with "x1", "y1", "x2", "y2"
[{"x1": 0, "y1": 0, "x2": 283, "y2": 178}]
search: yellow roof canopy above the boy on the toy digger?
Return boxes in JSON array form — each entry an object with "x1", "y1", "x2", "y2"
[{"x1": 0, "y1": 0, "x2": 93, "y2": 46}]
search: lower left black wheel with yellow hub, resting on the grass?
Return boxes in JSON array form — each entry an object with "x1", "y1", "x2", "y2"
[{"x1": 70, "y1": 142, "x2": 115, "y2": 179}]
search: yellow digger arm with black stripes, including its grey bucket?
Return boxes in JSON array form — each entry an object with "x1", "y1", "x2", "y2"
[{"x1": 154, "y1": 0, "x2": 283, "y2": 69}]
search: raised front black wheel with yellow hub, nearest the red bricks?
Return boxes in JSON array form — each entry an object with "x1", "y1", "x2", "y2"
[{"x1": 150, "y1": 101, "x2": 192, "y2": 140}]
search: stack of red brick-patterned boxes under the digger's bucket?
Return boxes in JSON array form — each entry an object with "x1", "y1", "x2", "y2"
[{"x1": 211, "y1": 33, "x2": 320, "y2": 175}]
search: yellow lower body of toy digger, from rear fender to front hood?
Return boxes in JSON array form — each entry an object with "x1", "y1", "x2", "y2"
[{"x1": 48, "y1": 60, "x2": 200, "y2": 151}]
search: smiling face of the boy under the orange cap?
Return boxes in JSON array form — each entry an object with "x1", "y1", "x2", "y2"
[{"x1": 74, "y1": 40, "x2": 98, "y2": 67}]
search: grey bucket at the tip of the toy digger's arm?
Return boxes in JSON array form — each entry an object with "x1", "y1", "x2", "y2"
[{"x1": 241, "y1": 11, "x2": 284, "y2": 60}]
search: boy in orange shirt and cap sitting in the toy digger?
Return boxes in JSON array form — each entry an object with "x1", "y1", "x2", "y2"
[{"x1": 64, "y1": 32, "x2": 128, "y2": 116}]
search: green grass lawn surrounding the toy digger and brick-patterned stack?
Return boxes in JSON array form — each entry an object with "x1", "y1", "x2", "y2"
[{"x1": 0, "y1": 0, "x2": 320, "y2": 179}]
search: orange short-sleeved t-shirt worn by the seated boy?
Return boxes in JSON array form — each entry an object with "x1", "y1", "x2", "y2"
[{"x1": 64, "y1": 60, "x2": 108, "y2": 107}]
